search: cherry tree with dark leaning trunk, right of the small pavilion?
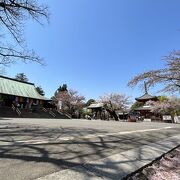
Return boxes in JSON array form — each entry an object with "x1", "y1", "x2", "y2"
[{"x1": 100, "y1": 93, "x2": 129, "y2": 121}]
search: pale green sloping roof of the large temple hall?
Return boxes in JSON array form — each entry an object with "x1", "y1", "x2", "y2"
[{"x1": 0, "y1": 76, "x2": 48, "y2": 100}]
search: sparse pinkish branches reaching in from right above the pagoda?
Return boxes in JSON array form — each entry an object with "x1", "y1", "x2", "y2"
[{"x1": 128, "y1": 51, "x2": 180, "y2": 93}]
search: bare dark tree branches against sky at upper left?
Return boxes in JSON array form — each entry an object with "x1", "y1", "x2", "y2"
[{"x1": 0, "y1": 0, "x2": 48, "y2": 66}]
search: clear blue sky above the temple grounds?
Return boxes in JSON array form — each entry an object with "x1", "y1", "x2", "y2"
[{"x1": 6, "y1": 0, "x2": 180, "y2": 99}]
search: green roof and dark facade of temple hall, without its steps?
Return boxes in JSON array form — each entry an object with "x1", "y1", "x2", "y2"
[{"x1": 0, "y1": 76, "x2": 49, "y2": 109}]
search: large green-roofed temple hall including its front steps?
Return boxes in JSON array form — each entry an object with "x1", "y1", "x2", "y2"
[{"x1": 0, "y1": 76, "x2": 70, "y2": 119}]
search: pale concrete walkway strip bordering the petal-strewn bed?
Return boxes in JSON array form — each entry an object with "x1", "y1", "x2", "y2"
[{"x1": 37, "y1": 135, "x2": 180, "y2": 180}]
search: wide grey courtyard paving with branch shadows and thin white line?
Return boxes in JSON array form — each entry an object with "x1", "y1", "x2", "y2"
[{"x1": 0, "y1": 118, "x2": 180, "y2": 180}]
